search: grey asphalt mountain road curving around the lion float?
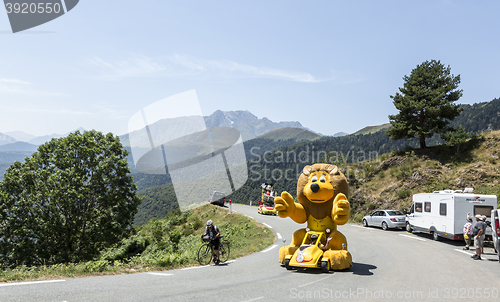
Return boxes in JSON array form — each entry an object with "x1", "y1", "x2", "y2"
[{"x1": 0, "y1": 205, "x2": 500, "y2": 302}]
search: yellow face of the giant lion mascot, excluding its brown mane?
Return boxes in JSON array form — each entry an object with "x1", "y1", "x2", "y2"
[{"x1": 303, "y1": 171, "x2": 335, "y2": 203}]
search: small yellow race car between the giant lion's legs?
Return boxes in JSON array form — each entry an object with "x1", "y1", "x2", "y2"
[{"x1": 285, "y1": 231, "x2": 331, "y2": 273}]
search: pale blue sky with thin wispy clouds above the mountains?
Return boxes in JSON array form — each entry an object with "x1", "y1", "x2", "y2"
[{"x1": 0, "y1": 0, "x2": 500, "y2": 136}]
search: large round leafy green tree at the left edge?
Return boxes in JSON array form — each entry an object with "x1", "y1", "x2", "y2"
[{"x1": 0, "y1": 130, "x2": 140, "y2": 267}]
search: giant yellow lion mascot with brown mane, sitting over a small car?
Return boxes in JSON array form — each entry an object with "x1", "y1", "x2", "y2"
[{"x1": 275, "y1": 164, "x2": 352, "y2": 270}]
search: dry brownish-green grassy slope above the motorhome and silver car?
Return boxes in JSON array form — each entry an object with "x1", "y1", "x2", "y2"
[{"x1": 349, "y1": 131, "x2": 500, "y2": 222}]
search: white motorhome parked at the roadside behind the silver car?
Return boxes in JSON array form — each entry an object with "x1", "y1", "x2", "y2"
[{"x1": 406, "y1": 188, "x2": 497, "y2": 240}]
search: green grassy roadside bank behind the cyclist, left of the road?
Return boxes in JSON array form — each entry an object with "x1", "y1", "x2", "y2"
[{"x1": 0, "y1": 204, "x2": 275, "y2": 282}]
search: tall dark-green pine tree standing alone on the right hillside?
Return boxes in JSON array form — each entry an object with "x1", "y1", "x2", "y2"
[{"x1": 387, "y1": 60, "x2": 462, "y2": 148}]
